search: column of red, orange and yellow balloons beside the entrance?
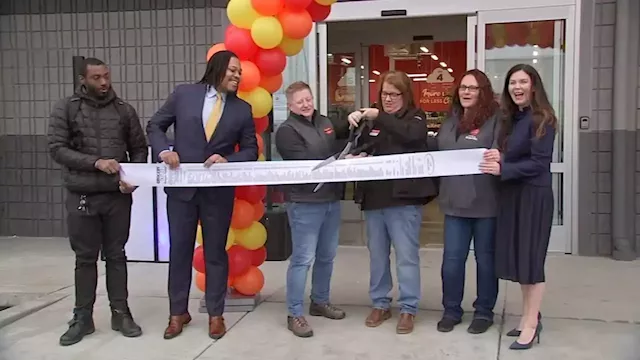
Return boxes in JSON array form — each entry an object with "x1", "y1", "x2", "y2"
[{"x1": 193, "y1": 0, "x2": 337, "y2": 296}]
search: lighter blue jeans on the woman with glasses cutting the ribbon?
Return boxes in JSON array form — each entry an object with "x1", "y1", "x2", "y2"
[{"x1": 365, "y1": 206, "x2": 422, "y2": 315}]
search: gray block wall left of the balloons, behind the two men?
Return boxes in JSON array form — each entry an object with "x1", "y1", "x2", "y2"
[{"x1": 0, "y1": 0, "x2": 226, "y2": 236}]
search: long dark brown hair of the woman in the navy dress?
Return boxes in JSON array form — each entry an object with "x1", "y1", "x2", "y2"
[{"x1": 498, "y1": 64, "x2": 558, "y2": 150}]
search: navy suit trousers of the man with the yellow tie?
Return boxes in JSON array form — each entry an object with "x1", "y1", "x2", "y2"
[{"x1": 167, "y1": 189, "x2": 233, "y2": 316}]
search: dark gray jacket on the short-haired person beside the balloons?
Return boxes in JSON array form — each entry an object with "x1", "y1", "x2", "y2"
[{"x1": 276, "y1": 111, "x2": 349, "y2": 202}]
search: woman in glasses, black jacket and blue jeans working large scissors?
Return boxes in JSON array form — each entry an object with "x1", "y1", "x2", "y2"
[{"x1": 340, "y1": 71, "x2": 437, "y2": 334}]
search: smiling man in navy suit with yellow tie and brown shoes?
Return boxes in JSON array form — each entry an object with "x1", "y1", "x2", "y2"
[{"x1": 147, "y1": 51, "x2": 258, "y2": 339}]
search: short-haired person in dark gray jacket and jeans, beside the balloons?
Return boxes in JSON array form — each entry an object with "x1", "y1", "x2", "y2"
[{"x1": 275, "y1": 82, "x2": 353, "y2": 337}]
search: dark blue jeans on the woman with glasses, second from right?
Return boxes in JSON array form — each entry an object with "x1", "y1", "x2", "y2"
[{"x1": 441, "y1": 215, "x2": 498, "y2": 320}]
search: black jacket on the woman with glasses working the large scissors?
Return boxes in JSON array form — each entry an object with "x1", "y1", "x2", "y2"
[{"x1": 352, "y1": 108, "x2": 438, "y2": 210}]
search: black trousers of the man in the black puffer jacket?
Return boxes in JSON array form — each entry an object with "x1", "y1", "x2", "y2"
[{"x1": 66, "y1": 192, "x2": 132, "y2": 311}]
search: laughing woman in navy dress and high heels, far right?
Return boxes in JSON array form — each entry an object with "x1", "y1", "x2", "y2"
[{"x1": 480, "y1": 64, "x2": 557, "y2": 350}]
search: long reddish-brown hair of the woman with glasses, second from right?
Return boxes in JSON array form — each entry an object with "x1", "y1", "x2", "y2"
[{"x1": 450, "y1": 69, "x2": 499, "y2": 134}]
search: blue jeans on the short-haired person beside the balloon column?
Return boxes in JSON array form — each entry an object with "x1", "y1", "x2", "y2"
[{"x1": 286, "y1": 201, "x2": 342, "y2": 317}]
